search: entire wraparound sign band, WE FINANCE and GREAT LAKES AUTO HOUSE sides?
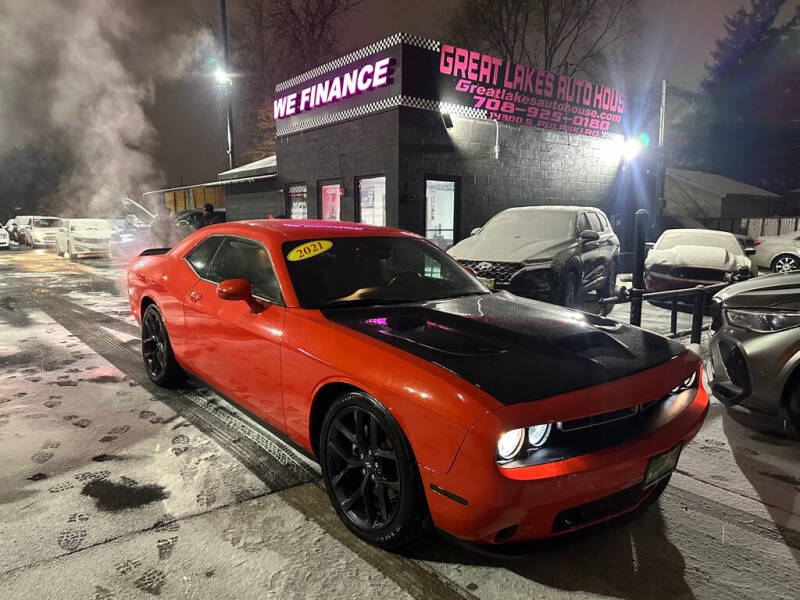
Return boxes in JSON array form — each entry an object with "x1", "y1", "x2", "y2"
[{"x1": 273, "y1": 33, "x2": 626, "y2": 138}]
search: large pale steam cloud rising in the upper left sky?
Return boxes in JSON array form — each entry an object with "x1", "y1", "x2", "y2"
[{"x1": 0, "y1": 0, "x2": 214, "y2": 216}]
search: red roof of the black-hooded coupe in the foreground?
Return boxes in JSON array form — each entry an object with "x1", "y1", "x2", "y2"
[{"x1": 204, "y1": 219, "x2": 419, "y2": 241}]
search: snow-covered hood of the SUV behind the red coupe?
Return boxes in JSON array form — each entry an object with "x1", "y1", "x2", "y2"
[{"x1": 447, "y1": 234, "x2": 570, "y2": 262}]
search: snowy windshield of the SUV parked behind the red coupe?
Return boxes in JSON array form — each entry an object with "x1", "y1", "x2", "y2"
[{"x1": 480, "y1": 210, "x2": 575, "y2": 240}]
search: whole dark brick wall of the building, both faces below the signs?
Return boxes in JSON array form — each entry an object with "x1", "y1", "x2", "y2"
[{"x1": 277, "y1": 108, "x2": 618, "y2": 238}]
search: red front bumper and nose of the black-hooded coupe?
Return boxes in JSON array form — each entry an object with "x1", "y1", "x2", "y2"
[{"x1": 423, "y1": 357, "x2": 708, "y2": 544}]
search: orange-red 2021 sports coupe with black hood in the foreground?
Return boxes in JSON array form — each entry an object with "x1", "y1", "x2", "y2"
[{"x1": 128, "y1": 220, "x2": 708, "y2": 548}]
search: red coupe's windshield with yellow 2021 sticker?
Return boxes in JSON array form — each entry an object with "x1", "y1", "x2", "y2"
[{"x1": 283, "y1": 237, "x2": 491, "y2": 308}]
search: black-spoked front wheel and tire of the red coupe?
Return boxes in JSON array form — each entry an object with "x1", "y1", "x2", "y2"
[{"x1": 318, "y1": 392, "x2": 430, "y2": 549}]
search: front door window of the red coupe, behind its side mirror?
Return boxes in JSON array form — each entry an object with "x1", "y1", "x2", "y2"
[{"x1": 207, "y1": 237, "x2": 283, "y2": 303}]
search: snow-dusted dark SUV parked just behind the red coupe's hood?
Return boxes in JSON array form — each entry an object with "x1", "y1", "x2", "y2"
[{"x1": 448, "y1": 206, "x2": 619, "y2": 306}]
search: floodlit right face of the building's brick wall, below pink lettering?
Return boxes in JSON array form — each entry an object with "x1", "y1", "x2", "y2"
[{"x1": 399, "y1": 108, "x2": 618, "y2": 238}]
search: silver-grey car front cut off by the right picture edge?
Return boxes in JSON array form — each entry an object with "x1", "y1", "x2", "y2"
[{"x1": 707, "y1": 273, "x2": 800, "y2": 433}]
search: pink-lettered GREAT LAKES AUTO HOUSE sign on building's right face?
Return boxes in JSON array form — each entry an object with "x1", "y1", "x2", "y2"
[{"x1": 438, "y1": 44, "x2": 626, "y2": 137}]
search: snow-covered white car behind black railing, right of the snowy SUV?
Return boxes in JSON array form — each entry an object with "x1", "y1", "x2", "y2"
[{"x1": 644, "y1": 229, "x2": 758, "y2": 292}]
